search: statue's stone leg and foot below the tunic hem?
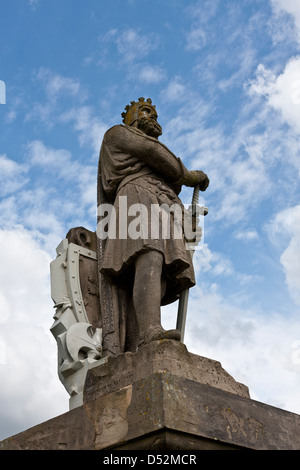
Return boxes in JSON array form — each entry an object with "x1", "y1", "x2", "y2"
[{"x1": 133, "y1": 250, "x2": 180, "y2": 344}]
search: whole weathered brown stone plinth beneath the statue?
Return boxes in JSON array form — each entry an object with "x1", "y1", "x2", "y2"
[{"x1": 0, "y1": 340, "x2": 300, "y2": 451}]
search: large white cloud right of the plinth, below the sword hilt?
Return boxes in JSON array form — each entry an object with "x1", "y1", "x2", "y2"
[{"x1": 187, "y1": 285, "x2": 300, "y2": 412}]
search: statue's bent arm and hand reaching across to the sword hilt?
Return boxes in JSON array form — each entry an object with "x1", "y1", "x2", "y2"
[{"x1": 106, "y1": 126, "x2": 209, "y2": 191}]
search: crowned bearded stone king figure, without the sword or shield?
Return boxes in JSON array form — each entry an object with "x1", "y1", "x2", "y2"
[{"x1": 96, "y1": 98, "x2": 209, "y2": 355}]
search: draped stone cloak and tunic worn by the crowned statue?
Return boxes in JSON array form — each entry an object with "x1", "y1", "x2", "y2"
[{"x1": 97, "y1": 125, "x2": 195, "y2": 355}]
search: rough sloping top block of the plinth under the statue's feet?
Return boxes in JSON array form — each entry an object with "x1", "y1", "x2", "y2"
[{"x1": 83, "y1": 340, "x2": 249, "y2": 403}]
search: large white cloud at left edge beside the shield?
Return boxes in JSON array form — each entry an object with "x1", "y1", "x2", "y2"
[{"x1": 0, "y1": 227, "x2": 68, "y2": 438}]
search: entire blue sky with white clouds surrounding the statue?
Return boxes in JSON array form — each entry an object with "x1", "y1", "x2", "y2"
[{"x1": 0, "y1": 0, "x2": 300, "y2": 438}]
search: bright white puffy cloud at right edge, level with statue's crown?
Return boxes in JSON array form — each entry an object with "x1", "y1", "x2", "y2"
[{"x1": 249, "y1": 57, "x2": 300, "y2": 133}]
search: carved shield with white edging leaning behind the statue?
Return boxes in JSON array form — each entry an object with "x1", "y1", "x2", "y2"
[{"x1": 50, "y1": 227, "x2": 102, "y2": 403}]
